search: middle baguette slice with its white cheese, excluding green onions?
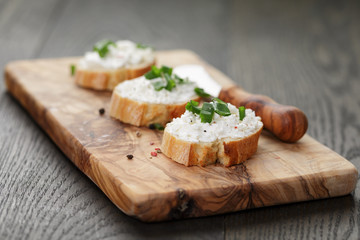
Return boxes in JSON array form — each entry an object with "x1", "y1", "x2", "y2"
[{"x1": 110, "y1": 76, "x2": 200, "y2": 127}]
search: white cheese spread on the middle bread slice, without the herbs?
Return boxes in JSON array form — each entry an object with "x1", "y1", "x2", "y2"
[{"x1": 115, "y1": 76, "x2": 197, "y2": 104}]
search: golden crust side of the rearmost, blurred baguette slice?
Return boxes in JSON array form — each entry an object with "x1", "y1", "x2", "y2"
[{"x1": 75, "y1": 60, "x2": 155, "y2": 90}]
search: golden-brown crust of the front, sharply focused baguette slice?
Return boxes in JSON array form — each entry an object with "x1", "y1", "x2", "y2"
[{"x1": 161, "y1": 127, "x2": 262, "y2": 167}]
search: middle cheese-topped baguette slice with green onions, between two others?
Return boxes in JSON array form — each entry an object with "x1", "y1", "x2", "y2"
[{"x1": 110, "y1": 63, "x2": 204, "y2": 128}]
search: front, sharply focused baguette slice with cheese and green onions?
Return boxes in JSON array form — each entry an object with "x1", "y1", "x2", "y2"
[{"x1": 161, "y1": 99, "x2": 263, "y2": 167}]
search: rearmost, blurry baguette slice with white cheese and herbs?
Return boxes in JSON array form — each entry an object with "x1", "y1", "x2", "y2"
[{"x1": 75, "y1": 40, "x2": 155, "y2": 90}]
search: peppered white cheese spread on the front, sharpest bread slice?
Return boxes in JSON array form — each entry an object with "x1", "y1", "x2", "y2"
[{"x1": 165, "y1": 103, "x2": 263, "y2": 142}]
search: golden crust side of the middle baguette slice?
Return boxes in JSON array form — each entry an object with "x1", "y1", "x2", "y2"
[{"x1": 110, "y1": 91, "x2": 200, "y2": 127}]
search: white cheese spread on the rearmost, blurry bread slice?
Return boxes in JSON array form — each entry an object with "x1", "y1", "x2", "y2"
[{"x1": 79, "y1": 40, "x2": 155, "y2": 69}]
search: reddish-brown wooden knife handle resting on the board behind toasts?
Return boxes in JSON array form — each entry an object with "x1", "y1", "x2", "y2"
[{"x1": 219, "y1": 86, "x2": 308, "y2": 142}]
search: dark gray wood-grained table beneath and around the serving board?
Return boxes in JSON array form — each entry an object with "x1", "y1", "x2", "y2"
[{"x1": 0, "y1": 0, "x2": 360, "y2": 239}]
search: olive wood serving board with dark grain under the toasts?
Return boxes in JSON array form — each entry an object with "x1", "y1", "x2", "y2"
[{"x1": 5, "y1": 50, "x2": 358, "y2": 221}]
